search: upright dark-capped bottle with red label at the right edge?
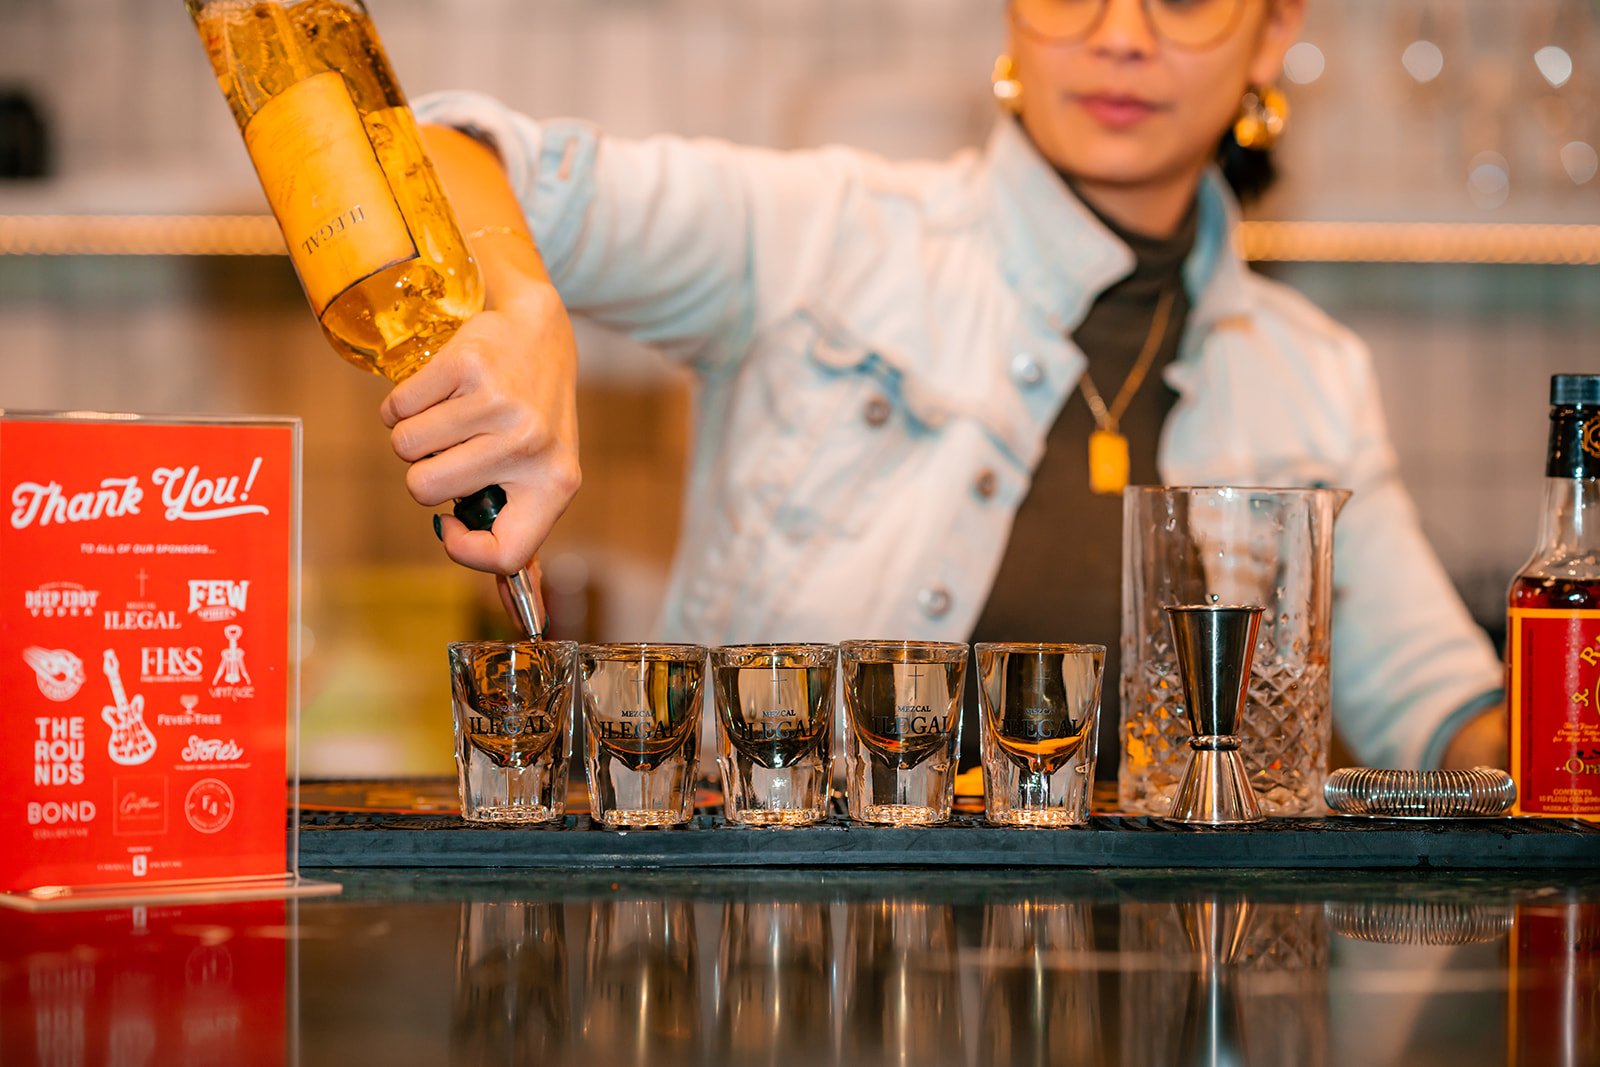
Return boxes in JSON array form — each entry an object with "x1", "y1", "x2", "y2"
[{"x1": 1506, "y1": 374, "x2": 1600, "y2": 821}]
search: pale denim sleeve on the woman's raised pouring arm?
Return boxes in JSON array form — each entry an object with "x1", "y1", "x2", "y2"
[{"x1": 418, "y1": 93, "x2": 851, "y2": 368}]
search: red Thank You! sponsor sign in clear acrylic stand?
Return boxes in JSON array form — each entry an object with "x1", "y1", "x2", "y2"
[{"x1": 0, "y1": 418, "x2": 299, "y2": 891}]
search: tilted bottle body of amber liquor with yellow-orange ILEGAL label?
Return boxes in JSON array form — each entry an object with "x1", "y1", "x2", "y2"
[{"x1": 189, "y1": 0, "x2": 483, "y2": 381}]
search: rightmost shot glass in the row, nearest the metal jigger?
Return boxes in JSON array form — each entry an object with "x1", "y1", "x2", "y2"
[{"x1": 978, "y1": 643, "x2": 1106, "y2": 827}]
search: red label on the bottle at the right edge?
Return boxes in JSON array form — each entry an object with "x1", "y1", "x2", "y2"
[{"x1": 1507, "y1": 608, "x2": 1600, "y2": 817}]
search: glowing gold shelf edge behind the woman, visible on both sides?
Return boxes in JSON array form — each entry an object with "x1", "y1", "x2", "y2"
[{"x1": 0, "y1": 214, "x2": 1600, "y2": 266}]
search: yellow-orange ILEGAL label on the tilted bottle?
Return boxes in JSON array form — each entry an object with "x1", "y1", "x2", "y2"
[{"x1": 245, "y1": 70, "x2": 416, "y2": 318}]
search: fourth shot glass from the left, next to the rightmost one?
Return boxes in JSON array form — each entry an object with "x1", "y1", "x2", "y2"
[{"x1": 838, "y1": 641, "x2": 966, "y2": 825}]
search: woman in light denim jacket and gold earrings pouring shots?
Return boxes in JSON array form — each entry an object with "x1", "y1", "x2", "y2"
[{"x1": 382, "y1": 0, "x2": 1499, "y2": 766}]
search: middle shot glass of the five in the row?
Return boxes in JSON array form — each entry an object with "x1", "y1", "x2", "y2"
[{"x1": 710, "y1": 645, "x2": 838, "y2": 825}]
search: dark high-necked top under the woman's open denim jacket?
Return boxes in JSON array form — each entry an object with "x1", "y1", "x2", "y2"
[{"x1": 962, "y1": 189, "x2": 1197, "y2": 777}]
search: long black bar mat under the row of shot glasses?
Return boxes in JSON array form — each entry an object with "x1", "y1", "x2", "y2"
[{"x1": 299, "y1": 811, "x2": 1600, "y2": 870}]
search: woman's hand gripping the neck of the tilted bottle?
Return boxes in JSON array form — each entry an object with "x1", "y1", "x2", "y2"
[{"x1": 381, "y1": 251, "x2": 581, "y2": 574}]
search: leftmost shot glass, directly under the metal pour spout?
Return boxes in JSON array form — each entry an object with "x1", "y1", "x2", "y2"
[{"x1": 450, "y1": 641, "x2": 578, "y2": 822}]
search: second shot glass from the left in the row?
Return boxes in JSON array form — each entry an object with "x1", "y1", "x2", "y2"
[{"x1": 582, "y1": 645, "x2": 706, "y2": 829}]
